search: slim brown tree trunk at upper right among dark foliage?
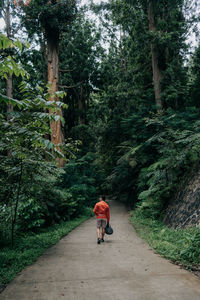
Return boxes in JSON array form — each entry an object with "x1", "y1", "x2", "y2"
[{"x1": 148, "y1": 0, "x2": 163, "y2": 111}]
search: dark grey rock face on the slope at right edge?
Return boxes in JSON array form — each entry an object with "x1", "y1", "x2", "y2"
[{"x1": 164, "y1": 171, "x2": 200, "y2": 229}]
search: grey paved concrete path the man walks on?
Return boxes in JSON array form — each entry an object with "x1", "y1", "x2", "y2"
[{"x1": 0, "y1": 202, "x2": 200, "y2": 300}]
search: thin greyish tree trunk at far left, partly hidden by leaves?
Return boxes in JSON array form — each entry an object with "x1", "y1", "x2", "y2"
[{"x1": 5, "y1": 0, "x2": 13, "y2": 119}]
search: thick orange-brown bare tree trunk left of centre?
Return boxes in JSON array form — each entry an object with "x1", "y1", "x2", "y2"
[{"x1": 47, "y1": 36, "x2": 64, "y2": 167}]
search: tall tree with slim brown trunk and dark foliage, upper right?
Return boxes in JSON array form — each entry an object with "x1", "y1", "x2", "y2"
[{"x1": 126, "y1": 0, "x2": 187, "y2": 110}]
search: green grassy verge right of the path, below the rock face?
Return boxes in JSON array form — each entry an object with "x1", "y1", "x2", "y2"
[{"x1": 131, "y1": 210, "x2": 200, "y2": 269}]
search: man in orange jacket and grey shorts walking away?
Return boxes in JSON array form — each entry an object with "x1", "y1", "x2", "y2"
[{"x1": 93, "y1": 196, "x2": 110, "y2": 244}]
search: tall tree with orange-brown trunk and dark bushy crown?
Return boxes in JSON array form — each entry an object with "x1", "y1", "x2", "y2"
[{"x1": 19, "y1": 0, "x2": 76, "y2": 166}]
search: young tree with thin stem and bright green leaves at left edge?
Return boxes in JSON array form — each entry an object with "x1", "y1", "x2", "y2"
[{"x1": 0, "y1": 34, "x2": 67, "y2": 245}]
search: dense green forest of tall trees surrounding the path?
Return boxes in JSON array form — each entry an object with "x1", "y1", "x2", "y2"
[{"x1": 0, "y1": 0, "x2": 200, "y2": 281}]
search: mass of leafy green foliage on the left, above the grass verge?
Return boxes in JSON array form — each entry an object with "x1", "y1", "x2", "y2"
[{"x1": 0, "y1": 32, "x2": 77, "y2": 244}]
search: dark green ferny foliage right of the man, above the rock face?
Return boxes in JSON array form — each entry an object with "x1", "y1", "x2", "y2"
[{"x1": 108, "y1": 108, "x2": 200, "y2": 217}]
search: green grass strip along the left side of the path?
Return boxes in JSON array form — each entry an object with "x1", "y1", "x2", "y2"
[{"x1": 0, "y1": 213, "x2": 91, "y2": 286}]
